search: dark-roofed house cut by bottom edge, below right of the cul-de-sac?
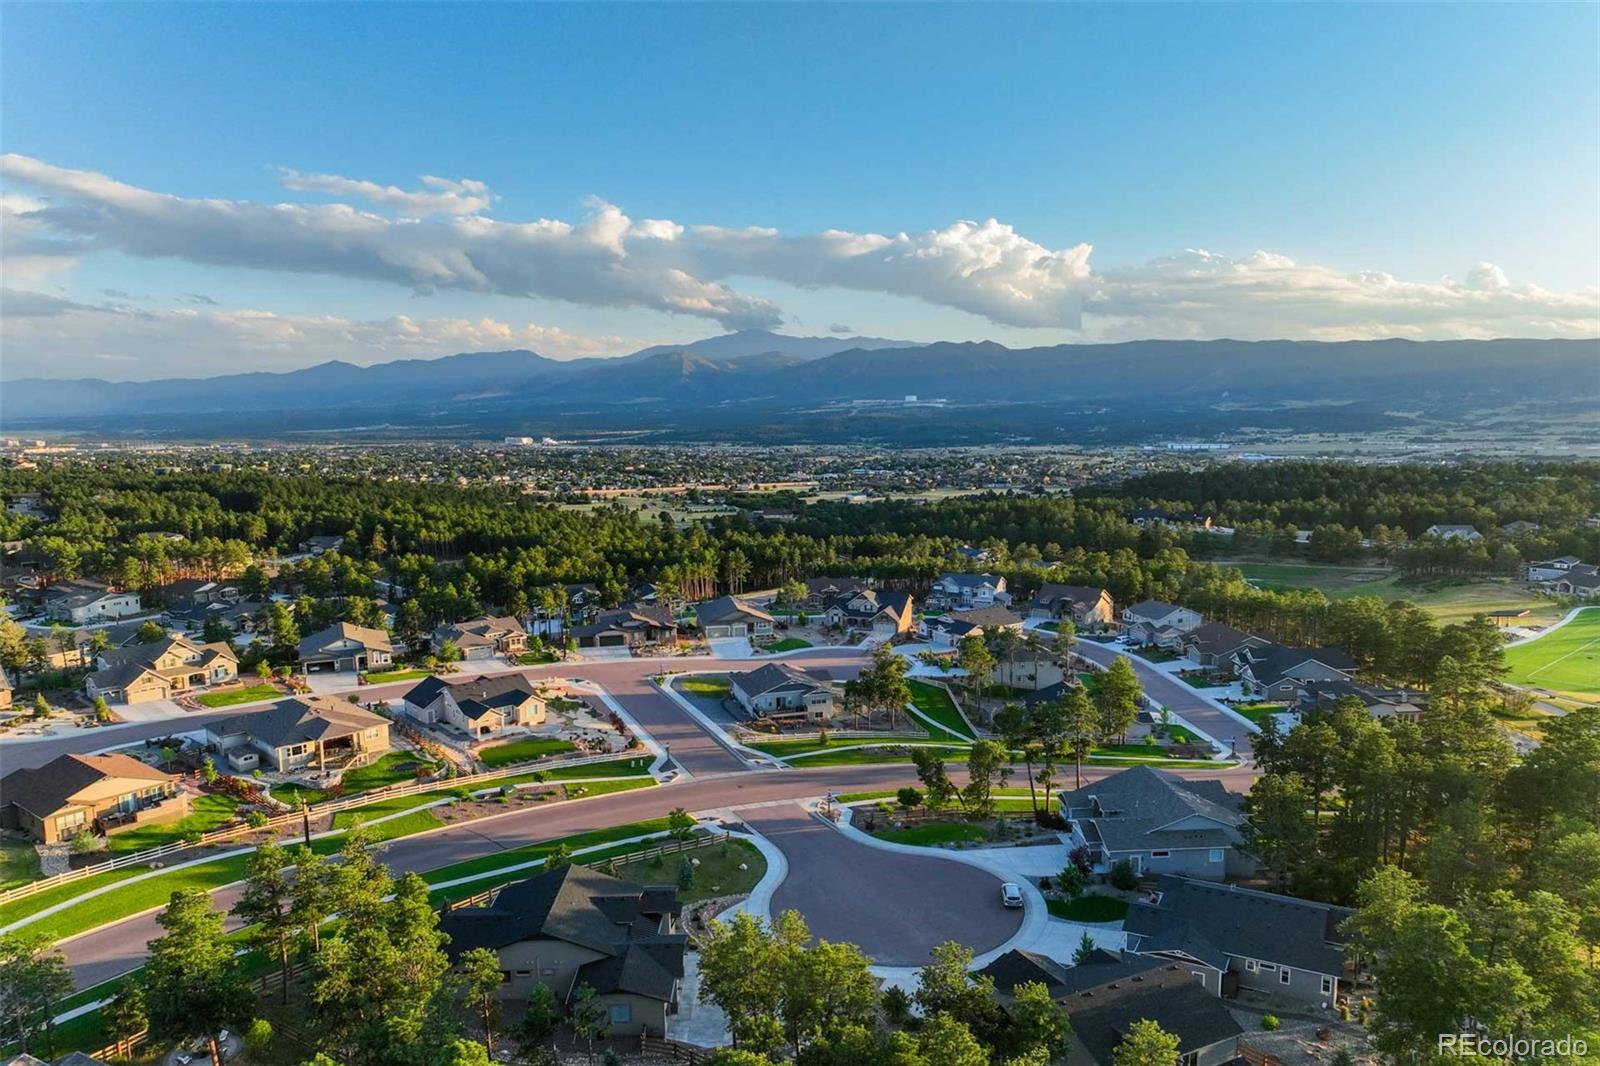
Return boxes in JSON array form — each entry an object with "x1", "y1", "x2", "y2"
[{"x1": 1049, "y1": 949, "x2": 1245, "y2": 1066}]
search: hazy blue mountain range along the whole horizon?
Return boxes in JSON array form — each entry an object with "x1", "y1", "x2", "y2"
[{"x1": 0, "y1": 330, "x2": 1600, "y2": 439}]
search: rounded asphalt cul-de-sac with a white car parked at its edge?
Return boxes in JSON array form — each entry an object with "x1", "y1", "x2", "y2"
[{"x1": 736, "y1": 804, "x2": 1022, "y2": 967}]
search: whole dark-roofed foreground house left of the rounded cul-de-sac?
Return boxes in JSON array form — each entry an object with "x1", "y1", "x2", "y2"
[{"x1": 438, "y1": 864, "x2": 686, "y2": 1037}]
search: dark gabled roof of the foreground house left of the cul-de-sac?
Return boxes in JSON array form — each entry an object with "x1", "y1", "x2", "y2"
[{"x1": 438, "y1": 864, "x2": 686, "y2": 999}]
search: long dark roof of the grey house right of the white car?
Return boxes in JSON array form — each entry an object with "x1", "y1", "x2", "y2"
[{"x1": 1123, "y1": 876, "x2": 1354, "y2": 975}]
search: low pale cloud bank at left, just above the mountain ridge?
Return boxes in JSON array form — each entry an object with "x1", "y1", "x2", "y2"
[{"x1": 0, "y1": 290, "x2": 638, "y2": 378}]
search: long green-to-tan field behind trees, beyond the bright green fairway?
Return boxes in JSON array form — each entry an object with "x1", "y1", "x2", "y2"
[{"x1": 1218, "y1": 563, "x2": 1565, "y2": 624}]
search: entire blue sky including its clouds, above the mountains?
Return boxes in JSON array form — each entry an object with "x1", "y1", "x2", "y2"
[{"x1": 0, "y1": 5, "x2": 1600, "y2": 378}]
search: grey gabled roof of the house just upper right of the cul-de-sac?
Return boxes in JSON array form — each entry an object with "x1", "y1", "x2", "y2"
[{"x1": 1059, "y1": 767, "x2": 1245, "y2": 852}]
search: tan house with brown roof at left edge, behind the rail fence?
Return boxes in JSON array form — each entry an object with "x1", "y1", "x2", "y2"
[{"x1": 0, "y1": 755, "x2": 189, "y2": 844}]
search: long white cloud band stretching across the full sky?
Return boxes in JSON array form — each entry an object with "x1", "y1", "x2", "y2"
[{"x1": 0, "y1": 155, "x2": 1600, "y2": 338}]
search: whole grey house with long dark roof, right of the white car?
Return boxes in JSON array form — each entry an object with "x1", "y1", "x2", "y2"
[{"x1": 1120, "y1": 876, "x2": 1354, "y2": 998}]
